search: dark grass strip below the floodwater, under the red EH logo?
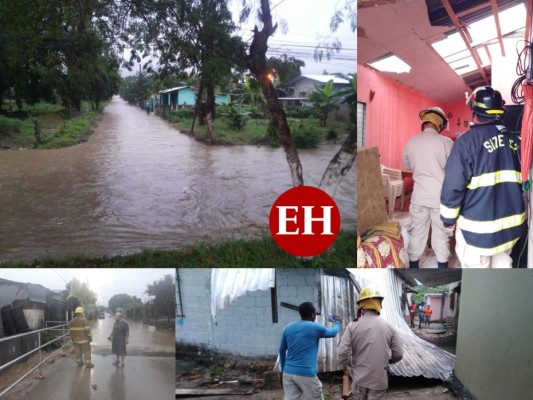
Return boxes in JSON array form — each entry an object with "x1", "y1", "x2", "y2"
[{"x1": 0, "y1": 230, "x2": 356, "y2": 268}]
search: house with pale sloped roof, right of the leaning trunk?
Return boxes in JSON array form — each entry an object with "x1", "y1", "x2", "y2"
[{"x1": 279, "y1": 75, "x2": 350, "y2": 106}]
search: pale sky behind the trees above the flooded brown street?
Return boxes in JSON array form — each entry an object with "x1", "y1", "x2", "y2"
[{"x1": 122, "y1": 0, "x2": 357, "y2": 75}]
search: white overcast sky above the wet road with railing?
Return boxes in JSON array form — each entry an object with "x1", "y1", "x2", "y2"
[{"x1": 0, "y1": 268, "x2": 176, "y2": 306}]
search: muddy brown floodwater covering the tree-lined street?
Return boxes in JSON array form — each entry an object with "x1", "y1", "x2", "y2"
[{"x1": 0, "y1": 97, "x2": 356, "y2": 261}]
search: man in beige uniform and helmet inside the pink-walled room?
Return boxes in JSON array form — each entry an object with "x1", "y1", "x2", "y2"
[{"x1": 402, "y1": 107, "x2": 453, "y2": 268}]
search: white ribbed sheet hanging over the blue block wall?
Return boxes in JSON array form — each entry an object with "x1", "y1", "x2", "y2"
[{"x1": 211, "y1": 268, "x2": 276, "y2": 318}]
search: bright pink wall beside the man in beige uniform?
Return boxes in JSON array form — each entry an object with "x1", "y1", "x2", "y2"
[{"x1": 357, "y1": 64, "x2": 464, "y2": 169}]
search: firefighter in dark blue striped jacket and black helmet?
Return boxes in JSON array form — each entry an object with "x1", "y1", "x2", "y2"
[{"x1": 440, "y1": 86, "x2": 526, "y2": 268}]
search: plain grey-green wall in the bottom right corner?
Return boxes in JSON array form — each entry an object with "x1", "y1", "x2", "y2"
[{"x1": 455, "y1": 269, "x2": 533, "y2": 400}]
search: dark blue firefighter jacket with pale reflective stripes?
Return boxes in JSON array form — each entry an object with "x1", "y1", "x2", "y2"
[{"x1": 440, "y1": 124, "x2": 526, "y2": 256}]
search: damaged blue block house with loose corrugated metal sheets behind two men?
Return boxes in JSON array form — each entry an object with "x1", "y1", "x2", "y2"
[{"x1": 176, "y1": 269, "x2": 454, "y2": 379}]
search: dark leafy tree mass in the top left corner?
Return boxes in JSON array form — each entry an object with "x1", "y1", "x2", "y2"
[{"x1": 0, "y1": 0, "x2": 120, "y2": 112}]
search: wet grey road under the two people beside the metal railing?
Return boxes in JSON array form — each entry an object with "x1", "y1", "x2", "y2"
[{"x1": 8, "y1": 315, "x2": 175, "y2": 400}]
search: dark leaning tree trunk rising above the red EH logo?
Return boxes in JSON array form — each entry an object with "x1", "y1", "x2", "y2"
[{"x1": 246, "y1": 0, "x2": 304, "y2": 187}]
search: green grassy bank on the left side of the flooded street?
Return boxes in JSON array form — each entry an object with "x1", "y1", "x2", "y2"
[{"x1": 0, "y1": 103, "x2": 107, "y2": 149}]
